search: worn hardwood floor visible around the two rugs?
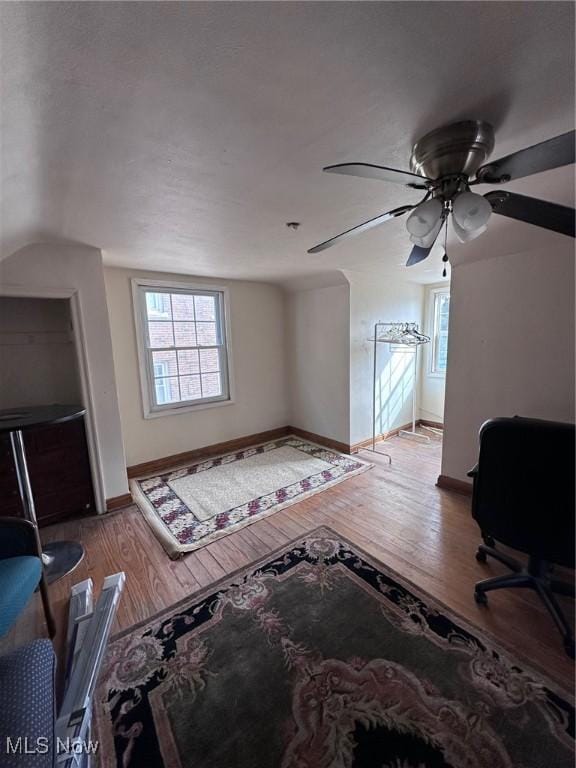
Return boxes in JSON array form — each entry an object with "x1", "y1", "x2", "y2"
[{"x1": 0, "y1": 437, "x2": 574, "y2": 688}]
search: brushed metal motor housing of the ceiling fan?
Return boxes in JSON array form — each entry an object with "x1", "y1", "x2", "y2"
[{"x1": 410, "y1": 120, "x2": 494, "y2": 179}]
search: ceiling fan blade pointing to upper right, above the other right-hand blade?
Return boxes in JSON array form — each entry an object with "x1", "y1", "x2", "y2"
[{"x1": 476, "y1": 131, "x2": 576, "y2": 184}]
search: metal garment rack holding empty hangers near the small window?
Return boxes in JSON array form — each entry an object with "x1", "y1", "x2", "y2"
[{"x1": 369, "y1": 322, "x2": 430, "y2": 464}]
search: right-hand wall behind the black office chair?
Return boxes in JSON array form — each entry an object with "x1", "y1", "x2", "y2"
[{"x1": 442, "y1": 246, "x2": 574, "y2": 480}]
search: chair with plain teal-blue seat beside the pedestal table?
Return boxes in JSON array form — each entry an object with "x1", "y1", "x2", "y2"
[{"x1": 0, "y1": 517, "x2": 56, "y2": 637}]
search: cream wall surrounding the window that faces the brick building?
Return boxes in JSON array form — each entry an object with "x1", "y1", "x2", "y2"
[{"x1": 105, "y1": 268, "x2": 288, "y2": 466}]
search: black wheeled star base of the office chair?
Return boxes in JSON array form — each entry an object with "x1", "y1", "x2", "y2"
[{"x1": 474, "y1": 544, "x2": 575, "y2": 659}]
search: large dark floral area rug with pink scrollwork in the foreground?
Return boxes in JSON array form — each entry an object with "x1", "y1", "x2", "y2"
[{"x1": 95, "y1": 528, "x2": 574, "y2": 768}]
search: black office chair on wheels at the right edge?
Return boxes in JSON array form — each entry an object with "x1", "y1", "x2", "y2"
[{"x1": 468, "y1": 416, "x2": 576, "y2": 658}]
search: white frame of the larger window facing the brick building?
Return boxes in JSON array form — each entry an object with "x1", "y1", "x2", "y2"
[{"x1": 131, "y1": 278, "x2": 234, "y2": 419}]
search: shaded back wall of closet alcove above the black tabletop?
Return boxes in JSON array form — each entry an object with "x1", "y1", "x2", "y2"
[{"x1": 0, "y1": 296, "x2": 82, "y2": 408}]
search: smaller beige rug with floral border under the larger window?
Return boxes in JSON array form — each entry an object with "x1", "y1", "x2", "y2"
[{"x1": 130, "y1": 436, "x2": 372, "y2": 558}]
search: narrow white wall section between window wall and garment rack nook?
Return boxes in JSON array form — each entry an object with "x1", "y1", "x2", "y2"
[{"x1": 287, "y1": 284, "x2": 350, "y2": 445}]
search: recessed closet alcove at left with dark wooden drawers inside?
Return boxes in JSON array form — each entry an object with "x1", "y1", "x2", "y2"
[{"x1": 0, "y1": 296, "x2": 95, "y2": 526}]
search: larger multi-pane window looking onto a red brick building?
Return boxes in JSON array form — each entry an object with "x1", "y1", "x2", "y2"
[{"x1": 133, "y1": 280, "x2": 230, "y2": 417}]
